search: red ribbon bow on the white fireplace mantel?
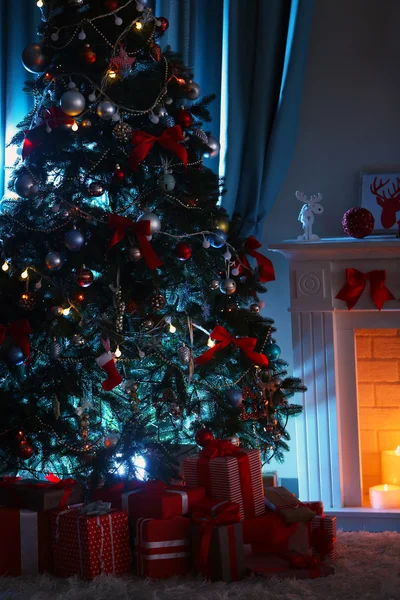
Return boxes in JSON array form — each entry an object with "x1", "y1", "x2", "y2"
[{"x1": 336, "y1": 269, "x2": 394, "y2": 310}]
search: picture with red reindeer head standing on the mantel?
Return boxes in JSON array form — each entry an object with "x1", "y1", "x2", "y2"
[{"x1": 361, "y1": 172, "x2": 400, "y2": 234}]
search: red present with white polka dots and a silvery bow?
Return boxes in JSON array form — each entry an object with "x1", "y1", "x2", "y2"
[{"x1": 52, "y1": 501, "x2": 131, "y2": 579}]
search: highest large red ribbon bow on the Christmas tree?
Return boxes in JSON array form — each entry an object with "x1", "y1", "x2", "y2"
[{"x1": 129, "y1": 125, "x2": 188, "y2": 171}]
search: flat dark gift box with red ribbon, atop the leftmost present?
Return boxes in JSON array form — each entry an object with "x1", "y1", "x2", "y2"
[{"x1": 0, "y1": 479, "x2": 83, "y2": 512}]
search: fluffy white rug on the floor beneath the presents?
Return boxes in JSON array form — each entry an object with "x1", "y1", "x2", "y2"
[{"x1": 0, "y1": 532, "x2": 400, "y2": 600}]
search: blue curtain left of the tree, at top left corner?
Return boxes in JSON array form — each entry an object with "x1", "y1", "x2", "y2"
[{"x1": 0, "y1": 0, "x2": 40, "y2": 198}]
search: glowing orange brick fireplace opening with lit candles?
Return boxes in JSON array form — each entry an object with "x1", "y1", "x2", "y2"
[{"x1": 355, "y1": 329, "x2": 400, "y2": 511}]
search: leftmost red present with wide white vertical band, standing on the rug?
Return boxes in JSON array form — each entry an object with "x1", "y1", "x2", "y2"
[{"x1": 0, "y1": 508, "x2": 53, "y2": 577}]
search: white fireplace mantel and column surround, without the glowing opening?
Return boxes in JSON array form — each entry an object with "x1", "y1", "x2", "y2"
[{"x1": 269, "y1": 236, "x2": 400, "y2": 509}]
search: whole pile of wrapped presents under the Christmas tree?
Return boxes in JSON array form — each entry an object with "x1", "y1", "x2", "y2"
[{"x1": 0, "y1": 440, "x2": 336, "y2": 582}]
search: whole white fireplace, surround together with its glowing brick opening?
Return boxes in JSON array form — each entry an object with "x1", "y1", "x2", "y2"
[{"x1": 270, "y1": 236, "x2": 400, "y2": 519}]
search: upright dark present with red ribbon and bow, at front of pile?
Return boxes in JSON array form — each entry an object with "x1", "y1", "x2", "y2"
[{"x1": 192, "y1": 499, "x2": 246, "y2": 582}]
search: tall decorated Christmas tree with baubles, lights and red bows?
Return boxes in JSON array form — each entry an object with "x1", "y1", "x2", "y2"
[{"x1": 0, "y1": 0, "x2": 304, "y2": 480}]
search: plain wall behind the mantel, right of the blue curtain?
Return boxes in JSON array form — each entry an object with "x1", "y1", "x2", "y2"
[{"x1": 263, "y1": 0, "x2": 400, "y2": 478}]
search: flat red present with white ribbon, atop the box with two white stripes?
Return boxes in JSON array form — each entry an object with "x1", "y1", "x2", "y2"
[{"x1": 122, "y1": 481, "x2": 206, "y2": 519}]
